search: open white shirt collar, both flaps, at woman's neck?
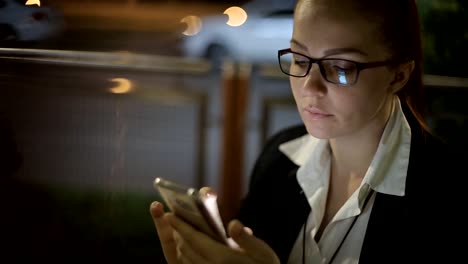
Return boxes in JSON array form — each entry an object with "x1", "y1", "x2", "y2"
[{"x1": 279, "y1": 97, "x2": 411, "y2": 196}]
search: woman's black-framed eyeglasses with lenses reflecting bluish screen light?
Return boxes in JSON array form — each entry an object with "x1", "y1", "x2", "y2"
[{"x1": 278, "y1": 49, "x2": 395, "y2": 86}]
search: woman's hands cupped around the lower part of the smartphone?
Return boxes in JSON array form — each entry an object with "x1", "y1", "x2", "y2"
[{"x1": 150, "y1": 202, "x2": 279, "y2": 264}]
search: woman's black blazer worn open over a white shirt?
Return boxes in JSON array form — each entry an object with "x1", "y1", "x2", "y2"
[{"x1": 239, "y1": 111, "x2": 468, "y2": 263}]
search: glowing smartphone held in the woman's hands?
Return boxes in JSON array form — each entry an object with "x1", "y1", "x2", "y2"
[{"x1": 154, "y1": 177, "x2": 229, "y2": 245}]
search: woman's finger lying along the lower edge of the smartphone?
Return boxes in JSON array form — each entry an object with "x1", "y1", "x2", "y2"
[{"x1": 166, "y1": 214, "x2": 228, "y2": 263}]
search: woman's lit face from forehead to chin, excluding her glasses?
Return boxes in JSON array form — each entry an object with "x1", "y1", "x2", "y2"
[{"x1": 290, "y1": 0, "x2": 395, "y2": 138}]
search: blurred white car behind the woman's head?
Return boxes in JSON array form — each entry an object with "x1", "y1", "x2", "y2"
[{"x1": 181, "y1": 0, "x2": 294, "y2": 66}]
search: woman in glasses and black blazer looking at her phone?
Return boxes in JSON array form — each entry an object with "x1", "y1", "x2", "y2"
[{"x1": 150, "y1": 0, "x2": 460, "y2": 264}]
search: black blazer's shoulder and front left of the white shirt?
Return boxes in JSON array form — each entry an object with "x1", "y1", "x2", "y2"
[{"x1": 238, "y1": 125, "x2": 310, "y2": 263}]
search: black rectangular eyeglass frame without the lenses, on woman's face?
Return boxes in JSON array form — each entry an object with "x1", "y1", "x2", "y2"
[{"x1": 278, "y1": 48, "x2": 401, "y2": 86}]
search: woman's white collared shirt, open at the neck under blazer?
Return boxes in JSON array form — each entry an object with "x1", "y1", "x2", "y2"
[{"x1": 279, "y1": 98, "x2": 411, "y2": 264}]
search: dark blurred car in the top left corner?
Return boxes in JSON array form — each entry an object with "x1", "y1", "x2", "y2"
[{"x1": 0, "y1": 0, "x2": 64, "y2": 42}]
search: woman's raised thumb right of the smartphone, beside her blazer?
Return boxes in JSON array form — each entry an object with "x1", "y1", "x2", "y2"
[{"x1": 228, "y1": 220, "x2": 280, "y2": 263}]
